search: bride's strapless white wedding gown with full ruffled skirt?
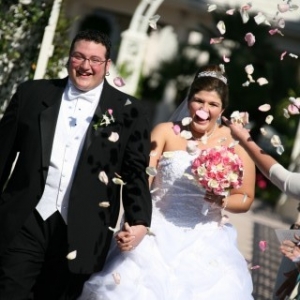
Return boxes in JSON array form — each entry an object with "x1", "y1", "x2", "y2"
[{"x1": 79, "y1": 151, "x2": 253, "y2": 300}]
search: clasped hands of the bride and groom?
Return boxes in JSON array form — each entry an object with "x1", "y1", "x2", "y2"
[{"x1": 115, "y1": 222, "x2": 147, "y2": 251}]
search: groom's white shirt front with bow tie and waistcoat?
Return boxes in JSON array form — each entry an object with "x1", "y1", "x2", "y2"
[{"x1": 36, "y1": 81, "x2": 103, "y2": 223}]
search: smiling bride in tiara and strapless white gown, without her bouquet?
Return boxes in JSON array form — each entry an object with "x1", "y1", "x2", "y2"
[{"x1": 79, "y1": 65, "x2": 255, "y2": 300}]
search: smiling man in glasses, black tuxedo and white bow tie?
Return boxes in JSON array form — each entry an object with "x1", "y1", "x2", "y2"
[{"x1": 0, "y1": 30, "x2": 152, "y2": 300}]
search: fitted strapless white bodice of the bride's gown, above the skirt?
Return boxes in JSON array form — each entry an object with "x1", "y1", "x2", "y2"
[{"x1": 151, "y1": 151, "x2": 222, "y2": 228}]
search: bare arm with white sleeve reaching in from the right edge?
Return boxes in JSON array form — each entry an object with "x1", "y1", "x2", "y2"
[{"x1": 222, "y1": 117, "x2": 300, "y2": 199}]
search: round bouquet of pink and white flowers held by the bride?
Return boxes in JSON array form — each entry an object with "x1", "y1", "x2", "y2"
[{"x1": 192, "y1": 146, "x2": 243, "y2": 214}]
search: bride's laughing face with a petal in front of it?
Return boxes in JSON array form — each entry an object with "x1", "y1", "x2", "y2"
[{"x1": 189, "y1": 91, "x2": 224, "y2": 134}]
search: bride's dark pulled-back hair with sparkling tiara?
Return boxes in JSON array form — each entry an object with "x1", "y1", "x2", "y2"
[{"x1": 188, "y1": 65, "x2": 228, "y2": 108}]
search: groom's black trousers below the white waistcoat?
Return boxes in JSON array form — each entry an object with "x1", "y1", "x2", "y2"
[{"x1": 0, "y1": 210, "x2": 89, "y2": 300}]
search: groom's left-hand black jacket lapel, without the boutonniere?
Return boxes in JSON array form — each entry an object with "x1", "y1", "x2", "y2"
[{"x1": 40, "y1": 78, "x2": 67, "y2": 179}]
